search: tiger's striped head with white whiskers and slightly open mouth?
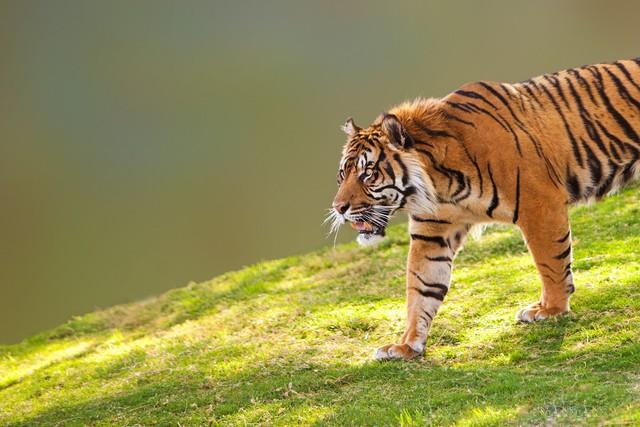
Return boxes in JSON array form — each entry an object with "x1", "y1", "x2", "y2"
[{"x1": 328, "y1": 113, "x2": 434, "y2": 245}]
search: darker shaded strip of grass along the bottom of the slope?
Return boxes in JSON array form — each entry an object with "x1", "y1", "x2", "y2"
[{"x1": 10, "y1": 328, "x2": 640, "y2": 426}]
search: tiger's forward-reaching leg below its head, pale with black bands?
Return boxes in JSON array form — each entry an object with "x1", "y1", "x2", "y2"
[{"x1": 374, "y1": 217, "x2": 469, "y2": 360}]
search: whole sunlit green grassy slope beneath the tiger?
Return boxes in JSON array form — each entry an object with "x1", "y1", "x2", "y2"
[{"x1": 0, "y1": 188, "x2": 640, "y2": 426}]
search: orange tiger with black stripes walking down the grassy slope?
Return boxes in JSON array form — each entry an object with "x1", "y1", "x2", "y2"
[{"x1": 330, "y1": 58, "x2": 640, "y2": 360}]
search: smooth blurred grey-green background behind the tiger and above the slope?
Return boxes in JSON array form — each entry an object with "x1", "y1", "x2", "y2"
[{"x1": 0, "y1": 0, "x2": 640, "y2": 343}]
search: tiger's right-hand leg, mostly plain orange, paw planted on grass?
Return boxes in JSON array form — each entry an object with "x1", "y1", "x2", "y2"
[{"x1": 516, "y1": 203, "x2": 575, "y2": 322}]
